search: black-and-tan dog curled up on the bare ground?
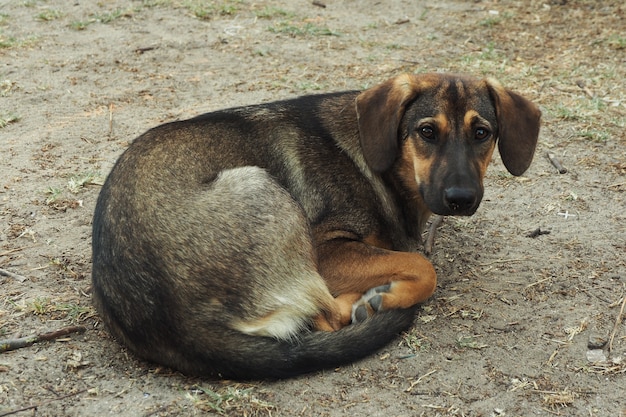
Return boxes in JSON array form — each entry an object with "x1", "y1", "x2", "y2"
[{"x1": 92, "y1": 74, "x2": 541, "y2": 379}]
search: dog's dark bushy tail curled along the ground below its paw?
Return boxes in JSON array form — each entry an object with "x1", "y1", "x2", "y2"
[{"x1": 179, "y1": 306, "x2": 417, "y2": 380}]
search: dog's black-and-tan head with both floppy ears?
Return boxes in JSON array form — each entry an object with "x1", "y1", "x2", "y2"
[{"x1": 356, "y1": 74, "x2": 541, "y2": 216}]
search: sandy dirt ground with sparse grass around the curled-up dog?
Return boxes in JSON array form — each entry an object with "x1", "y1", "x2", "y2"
[{"x1": 0, "y1": 0, "x2": 626, "y2": 417}]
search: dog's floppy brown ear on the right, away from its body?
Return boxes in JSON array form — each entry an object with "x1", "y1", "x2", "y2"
[{"x1": 487, "y1": 79, "x2": 541, "y2": 175}]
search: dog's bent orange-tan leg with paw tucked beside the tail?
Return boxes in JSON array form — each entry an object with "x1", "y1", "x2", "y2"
[{"x1": 318, "y1": 241, "x2": 437, "y2": 325}]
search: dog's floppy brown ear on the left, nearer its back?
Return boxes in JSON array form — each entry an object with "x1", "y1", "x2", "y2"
[{"x1": 356, "y1": 74, "x2": 417, "y2": 172}]
